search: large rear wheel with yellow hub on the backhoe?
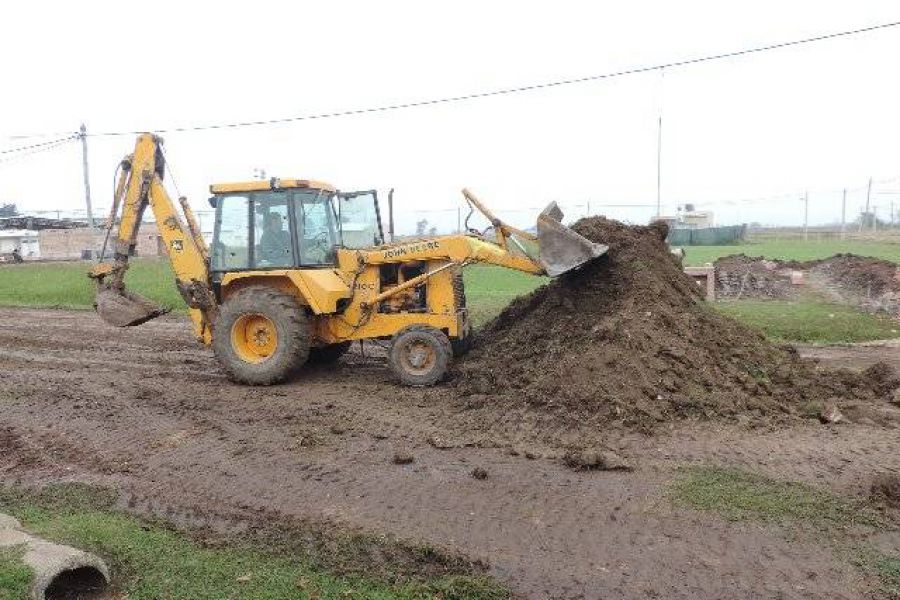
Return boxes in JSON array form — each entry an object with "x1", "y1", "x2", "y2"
[{"x1": 212, "y1": 286, "x2": 310, "y2": 385}]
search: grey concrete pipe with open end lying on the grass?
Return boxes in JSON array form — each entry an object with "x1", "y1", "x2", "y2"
[{"x1": 0, "y1": 513, "x2": 109, "y2": 600}]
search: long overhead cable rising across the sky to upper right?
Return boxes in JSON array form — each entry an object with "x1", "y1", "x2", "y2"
[{"x1": 8, "y1": 21, "x2": 900, "y2": 137}]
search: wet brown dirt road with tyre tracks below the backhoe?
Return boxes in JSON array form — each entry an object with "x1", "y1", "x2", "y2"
[{"x1": 0, "y1": 309, "x2": 900, "y2": 598}]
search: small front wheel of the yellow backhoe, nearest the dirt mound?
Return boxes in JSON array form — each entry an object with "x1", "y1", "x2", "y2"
[{"x1": 388, "y1": 325, "x2": 453, "y2": 387}]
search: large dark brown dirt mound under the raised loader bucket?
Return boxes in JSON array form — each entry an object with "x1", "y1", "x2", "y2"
[{"x1": 457, "y1": 218, "x2": 895, "y2": 430}]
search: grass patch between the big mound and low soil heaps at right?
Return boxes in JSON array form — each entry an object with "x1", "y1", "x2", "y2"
[{"x1": 714, "y1": 299, "x2": 900, "y2": 344}]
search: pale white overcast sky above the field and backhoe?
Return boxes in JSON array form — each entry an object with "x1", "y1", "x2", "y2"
[{"x1": 0, "y1": 0, "x2": 900, "y2": 231}]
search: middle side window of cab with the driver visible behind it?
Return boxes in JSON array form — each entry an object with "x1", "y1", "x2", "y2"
[{"x1": 253, "y1": 193, "x2": 294, "y2": 269}]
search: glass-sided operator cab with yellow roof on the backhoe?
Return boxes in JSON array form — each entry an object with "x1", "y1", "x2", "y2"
[{"x1": 210, "y1": 179, "x2": 384, "y2": 273}]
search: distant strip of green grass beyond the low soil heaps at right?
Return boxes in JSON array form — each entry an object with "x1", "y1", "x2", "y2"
[{"x1": 684, "y1": 240, "x2": 900, "y2": 266}]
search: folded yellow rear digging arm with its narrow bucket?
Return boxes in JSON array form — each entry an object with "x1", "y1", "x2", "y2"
[{"x1": 89, "y1": 133, "x2": 216, "y2": 343}]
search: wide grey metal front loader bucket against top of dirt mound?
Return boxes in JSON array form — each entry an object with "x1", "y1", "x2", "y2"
[{"x1": 537, "y1": 202, "x2": 609, "y2": 277}]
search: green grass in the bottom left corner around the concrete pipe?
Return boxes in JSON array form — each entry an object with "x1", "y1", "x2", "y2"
[{"x1": 0, "y1": 484, "x2": 509, "y2": 600}]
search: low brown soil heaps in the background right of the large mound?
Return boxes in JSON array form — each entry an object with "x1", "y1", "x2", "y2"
[{"x1": 715, "y1": 254, "x2": 900, "y2": 318}]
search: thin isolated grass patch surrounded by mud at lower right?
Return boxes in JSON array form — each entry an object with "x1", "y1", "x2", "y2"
[{"x1": 671, "y1": 466, "x2": 880, "y2": 526}]
